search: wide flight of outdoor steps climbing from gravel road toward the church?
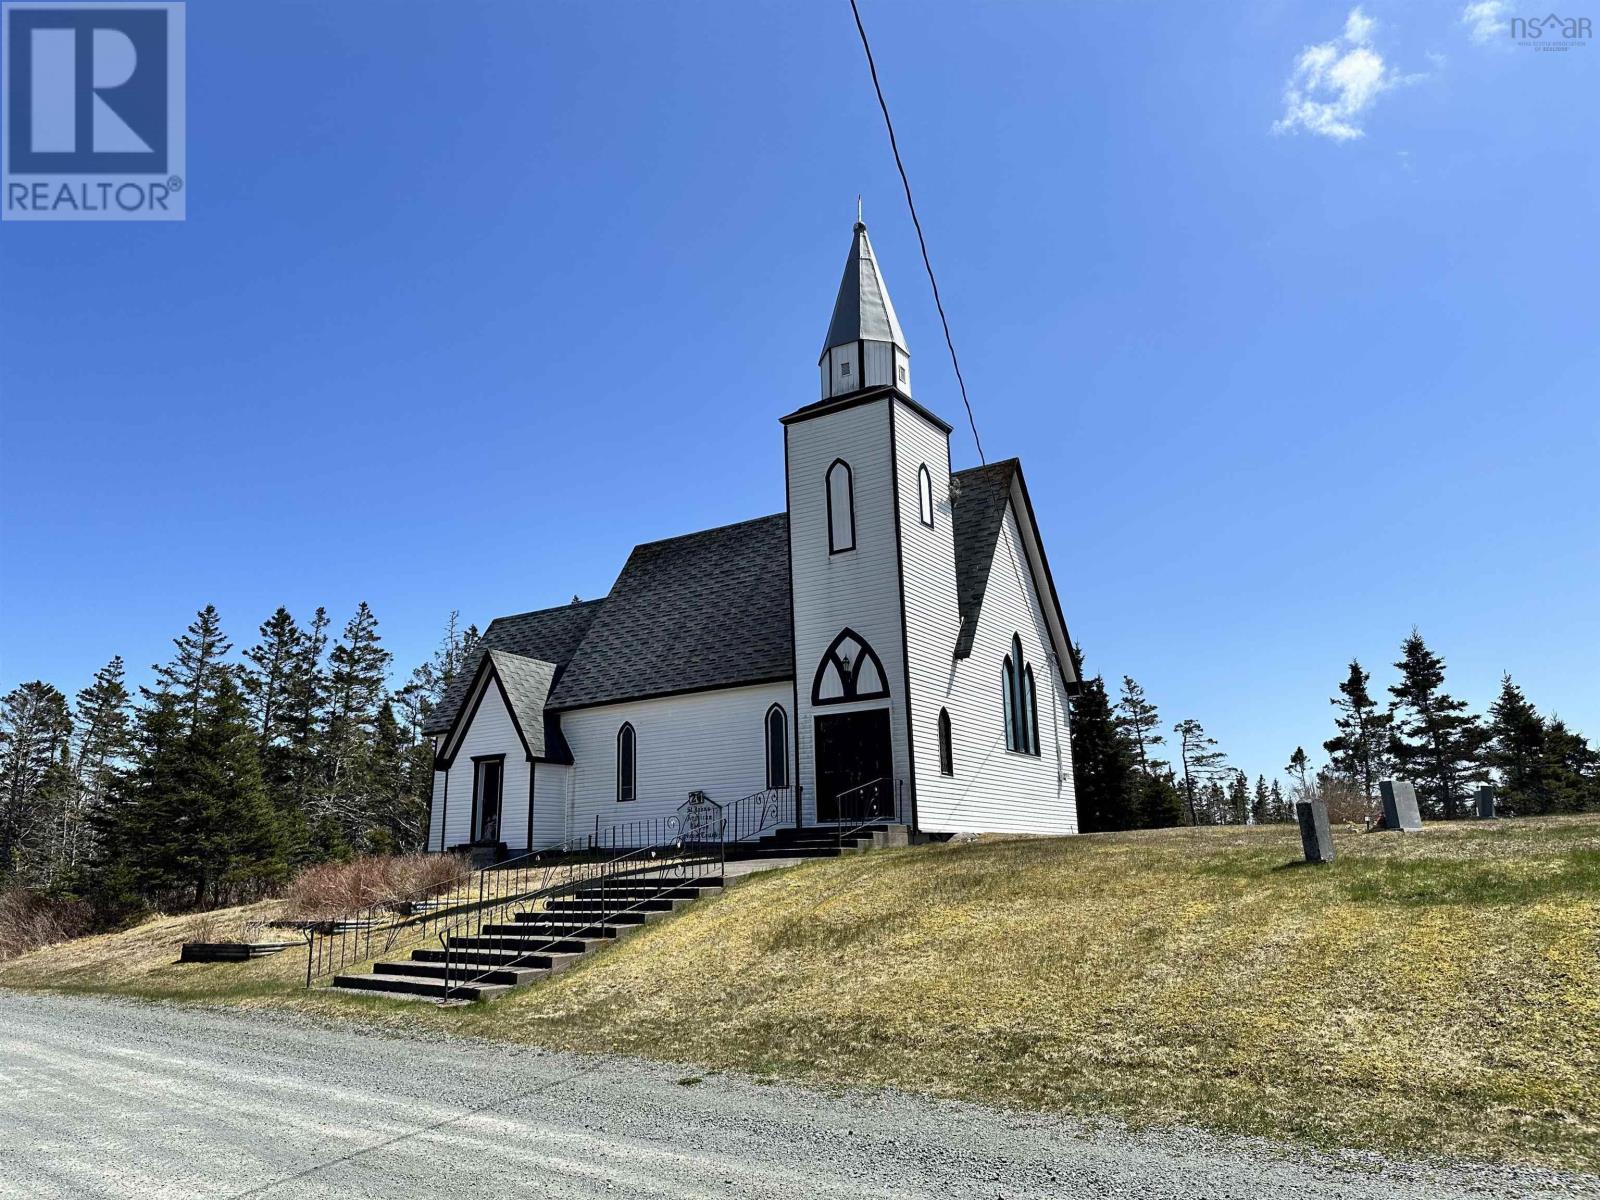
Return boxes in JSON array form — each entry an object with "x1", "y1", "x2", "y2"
[{"x1": 331, "y1": 875, "x2": 723, "y2": 1000}]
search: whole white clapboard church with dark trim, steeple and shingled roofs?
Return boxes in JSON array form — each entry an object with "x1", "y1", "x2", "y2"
[{"x1": 426, "y1": 221, "x2": 1077, "y2": 856}]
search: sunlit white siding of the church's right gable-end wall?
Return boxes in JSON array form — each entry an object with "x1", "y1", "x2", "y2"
[{"x1": 912, "y1": 493, "x2": 1078, "y2": 834}]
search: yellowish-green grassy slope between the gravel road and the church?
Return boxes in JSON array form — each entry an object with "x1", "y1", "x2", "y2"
[{"x1": 0, "y1": 818, "x2": 1600, "y2": 1170}]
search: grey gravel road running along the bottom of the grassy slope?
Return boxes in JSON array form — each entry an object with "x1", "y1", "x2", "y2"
[{"x1": 0, "y1": 994, "x2": 1600, "y2": 1200}]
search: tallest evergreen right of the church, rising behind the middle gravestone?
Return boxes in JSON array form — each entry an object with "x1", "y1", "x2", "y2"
[{"x1": 1389, "y1": 629, "x2": 1488, "y2": 821}]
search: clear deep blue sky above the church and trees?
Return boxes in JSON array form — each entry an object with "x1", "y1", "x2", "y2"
[{"x1": 0, "y1": 0, "x2": 1600, "y2": 784}]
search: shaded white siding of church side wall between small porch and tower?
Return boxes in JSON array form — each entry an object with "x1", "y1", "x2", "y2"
[{"x1": 556, "y1": 684, "x2": 793, "y2": 837}]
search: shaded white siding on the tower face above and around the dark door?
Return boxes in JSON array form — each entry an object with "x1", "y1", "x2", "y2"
[{"x1": 784, "y1": 398, "x2": 915, "y2": 821}]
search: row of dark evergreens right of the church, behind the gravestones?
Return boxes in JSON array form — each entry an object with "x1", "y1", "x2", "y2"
[{"x1": 1072, "y1": 630, "x2": 1600, "y2": 832}]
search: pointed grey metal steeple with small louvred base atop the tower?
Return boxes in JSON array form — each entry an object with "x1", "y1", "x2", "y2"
[{"x1": 818, "y1": 214, "x2": 910, "y2": 400}]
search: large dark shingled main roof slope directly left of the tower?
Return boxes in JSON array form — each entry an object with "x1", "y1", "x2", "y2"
[{"x1": 550, "y1": 512, "x2": 794, "y2": 709}]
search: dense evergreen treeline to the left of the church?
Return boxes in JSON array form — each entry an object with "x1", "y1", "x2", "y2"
[{"x1": 0, "y1": 603, "x2": 477, "y2": 925}]
